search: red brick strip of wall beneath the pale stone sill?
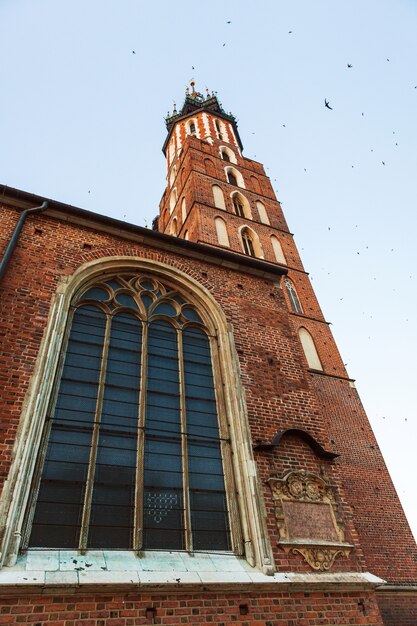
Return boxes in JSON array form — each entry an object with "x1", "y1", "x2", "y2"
[{"x1": 0, "y1": 592, "x2": 384, "y2": 626}]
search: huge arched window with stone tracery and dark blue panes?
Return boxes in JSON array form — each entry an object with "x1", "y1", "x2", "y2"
[{"x1": 23, "y1": 273, "x2": 237, "y2": 551}]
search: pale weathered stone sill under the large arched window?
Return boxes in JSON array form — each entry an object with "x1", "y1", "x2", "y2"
[{"x1": 0, "y1": 550, "x2": 384, "y2": 596}]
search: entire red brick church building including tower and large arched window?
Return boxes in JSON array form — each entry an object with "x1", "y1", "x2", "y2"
[{"x1": 0, "y1": 84, "x2": 417, "y2": 626}]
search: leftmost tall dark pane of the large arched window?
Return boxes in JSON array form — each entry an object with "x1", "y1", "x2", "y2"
[{"x1": 29, "y1": 308, "x2": 107, "y2": 548}]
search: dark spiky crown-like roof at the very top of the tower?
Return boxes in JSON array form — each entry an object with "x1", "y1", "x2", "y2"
[{"x1": 162, "y1": 80, "x2": 243, "y2": 154}]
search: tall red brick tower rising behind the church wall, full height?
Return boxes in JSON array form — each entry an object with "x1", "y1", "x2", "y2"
[{"x1": 157, "y1": 81, "x2": 417, "y2": 624}]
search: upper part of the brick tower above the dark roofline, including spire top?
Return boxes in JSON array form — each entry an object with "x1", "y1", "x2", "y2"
[{"x1": 158, "y1": 80, "x2": 290, "y2": 265}]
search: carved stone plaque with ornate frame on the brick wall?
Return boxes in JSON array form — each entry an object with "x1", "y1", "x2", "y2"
[{"x1": 269, "y1": 470, "x2": 352, "y2": 571}]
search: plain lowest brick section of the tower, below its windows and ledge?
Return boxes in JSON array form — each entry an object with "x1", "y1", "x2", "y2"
[{"x1": 311, "y1": 374, "x2": 417, "y2": 583}]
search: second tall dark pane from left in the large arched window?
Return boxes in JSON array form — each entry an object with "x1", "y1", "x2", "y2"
[{"x1": 88, "y1": 313, "x2": 142, "y2": 549}]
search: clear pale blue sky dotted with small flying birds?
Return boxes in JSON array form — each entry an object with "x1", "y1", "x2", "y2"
[{"x1": 0, "y1": 0, "x2": 417, "y2": 535}]
